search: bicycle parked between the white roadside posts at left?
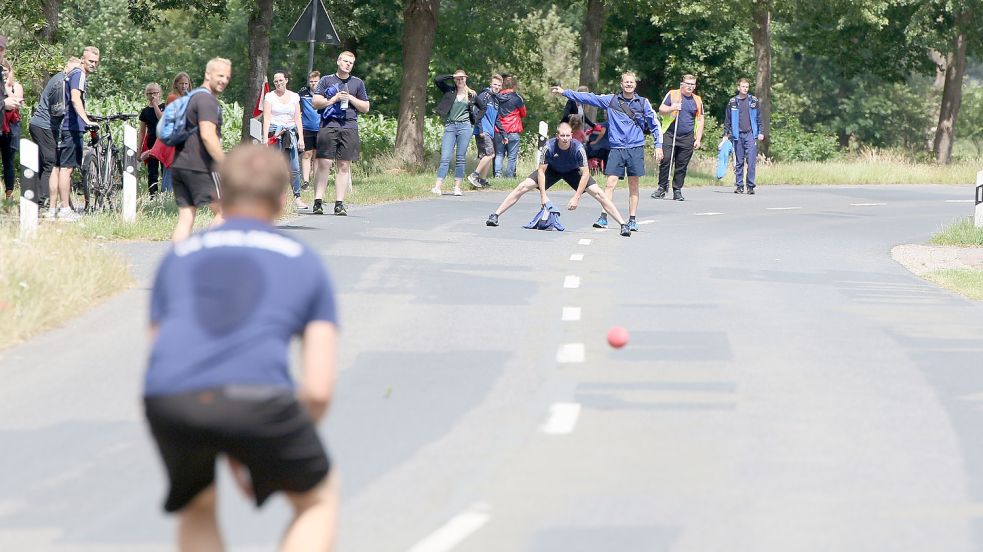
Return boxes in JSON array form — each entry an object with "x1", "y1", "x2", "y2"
[{"x1": 70, "y1": 113, "x2": 138, "y2": 213}]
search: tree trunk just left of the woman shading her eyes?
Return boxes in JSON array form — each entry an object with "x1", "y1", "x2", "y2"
[{"x1": 396, "y1": 0, "x2": 440, "y2": 165}]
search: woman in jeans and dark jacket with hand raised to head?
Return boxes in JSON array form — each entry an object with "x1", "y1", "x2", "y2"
[{"x1": 430, "y1": 69, "x2": 477, "y2": 196}]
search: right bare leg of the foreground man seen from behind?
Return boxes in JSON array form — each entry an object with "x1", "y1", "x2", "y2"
[{"x1": 280, "y1": 471, "x2": 338, "y2": 552}]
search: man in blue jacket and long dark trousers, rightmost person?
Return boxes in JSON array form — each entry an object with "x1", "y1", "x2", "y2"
[{"x1": 724, "y1": 79, "x2": 765, "y2": 195}]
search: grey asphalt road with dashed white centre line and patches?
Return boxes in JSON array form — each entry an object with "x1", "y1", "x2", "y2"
[{"x1": 0, "y1": 186, "x2": 983, "y2": 552}]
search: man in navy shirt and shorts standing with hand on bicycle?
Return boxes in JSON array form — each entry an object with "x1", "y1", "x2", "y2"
[{"x1": 54, "y1": 46, "x2": 99, "y2": 222}]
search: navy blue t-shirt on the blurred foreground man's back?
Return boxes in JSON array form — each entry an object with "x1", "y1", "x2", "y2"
[{"x1": 144, "y1": 219, "x2": 338, "y2": 397}]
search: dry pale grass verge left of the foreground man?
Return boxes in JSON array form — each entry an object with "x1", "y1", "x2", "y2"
[{"x1": 0, "y1": 224, "x2": 131, "y2": 349}]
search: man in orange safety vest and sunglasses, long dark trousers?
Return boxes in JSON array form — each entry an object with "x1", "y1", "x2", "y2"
[{"x1": 652, "y1": 74, "x2": 703, "y2": 201}]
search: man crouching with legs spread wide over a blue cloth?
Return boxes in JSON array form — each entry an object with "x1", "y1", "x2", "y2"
[{"x1": 485, "y1": 123, "x2": 631, "y2": 237}]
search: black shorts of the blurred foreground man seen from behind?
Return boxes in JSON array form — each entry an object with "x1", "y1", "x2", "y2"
[{"x1": 144, "y1": 388, "x2": 331, "y2": 512}]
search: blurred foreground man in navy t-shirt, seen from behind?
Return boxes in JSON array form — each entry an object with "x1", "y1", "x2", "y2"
[{"x1": 144, "y1": 145, "x2": 337, "y2": 552}]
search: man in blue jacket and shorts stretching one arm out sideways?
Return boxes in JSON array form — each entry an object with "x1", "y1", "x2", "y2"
[{"x1": 552, "y1": 72, "x2": 662, "y2": 232}]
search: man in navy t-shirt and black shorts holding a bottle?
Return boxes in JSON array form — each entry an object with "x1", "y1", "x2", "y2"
[{"x1": 313, "y1": 51, "x2": 369, "y2": 216}]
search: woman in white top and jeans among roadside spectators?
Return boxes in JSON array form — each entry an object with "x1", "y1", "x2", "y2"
[{"x1": 263, "y1": 71, "x2": 307, "y2": 209}]
